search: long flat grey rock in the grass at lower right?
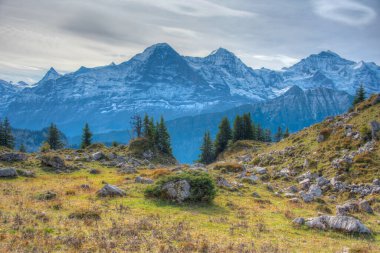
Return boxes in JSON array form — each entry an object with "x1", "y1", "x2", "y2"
[{"x1": 305, "y1": 215, "x2": 371, "y2": 234}]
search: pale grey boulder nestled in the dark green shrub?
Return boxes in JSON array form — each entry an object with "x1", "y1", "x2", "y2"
[{"x1": 162, "y1": 180, "x2": 191, "y2": 203}]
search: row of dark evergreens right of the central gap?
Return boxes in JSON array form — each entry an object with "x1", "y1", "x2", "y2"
[{"x1": 198, "y1": 113, "x2": 272, "y2": 164}]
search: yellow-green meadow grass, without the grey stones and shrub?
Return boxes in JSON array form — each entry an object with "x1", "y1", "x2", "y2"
[{"x1": 0, "y1": 98, "x2": 380, "y2": 252}]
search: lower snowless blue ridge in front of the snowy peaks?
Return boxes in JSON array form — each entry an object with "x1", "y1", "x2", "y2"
[{"x1": 167, "y1": 86, "x2": 352, "y2": 162}]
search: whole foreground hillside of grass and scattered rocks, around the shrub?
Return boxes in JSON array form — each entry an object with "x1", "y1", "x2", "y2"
[{"x1": 0, "y1": 96, "x2": 380, "y2": 252}]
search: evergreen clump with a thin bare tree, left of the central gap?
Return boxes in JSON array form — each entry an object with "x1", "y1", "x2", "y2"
[{"x1": 142, "y1": 114, "x2": 172, "y2": 156}]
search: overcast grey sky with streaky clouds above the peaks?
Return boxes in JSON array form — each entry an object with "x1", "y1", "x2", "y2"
[{"x1": 0, "y1": 0, "x2": 380, "y2": 83}]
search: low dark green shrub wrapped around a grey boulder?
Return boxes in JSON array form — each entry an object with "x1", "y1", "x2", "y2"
[{"x1": 145, "y1": 172, "x2": 216, "y2": 202}]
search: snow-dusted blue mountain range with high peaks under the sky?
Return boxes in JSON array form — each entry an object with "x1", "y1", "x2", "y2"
[{"x1": 0, "y1": 43, "x2": 380, "y2": 136}]
